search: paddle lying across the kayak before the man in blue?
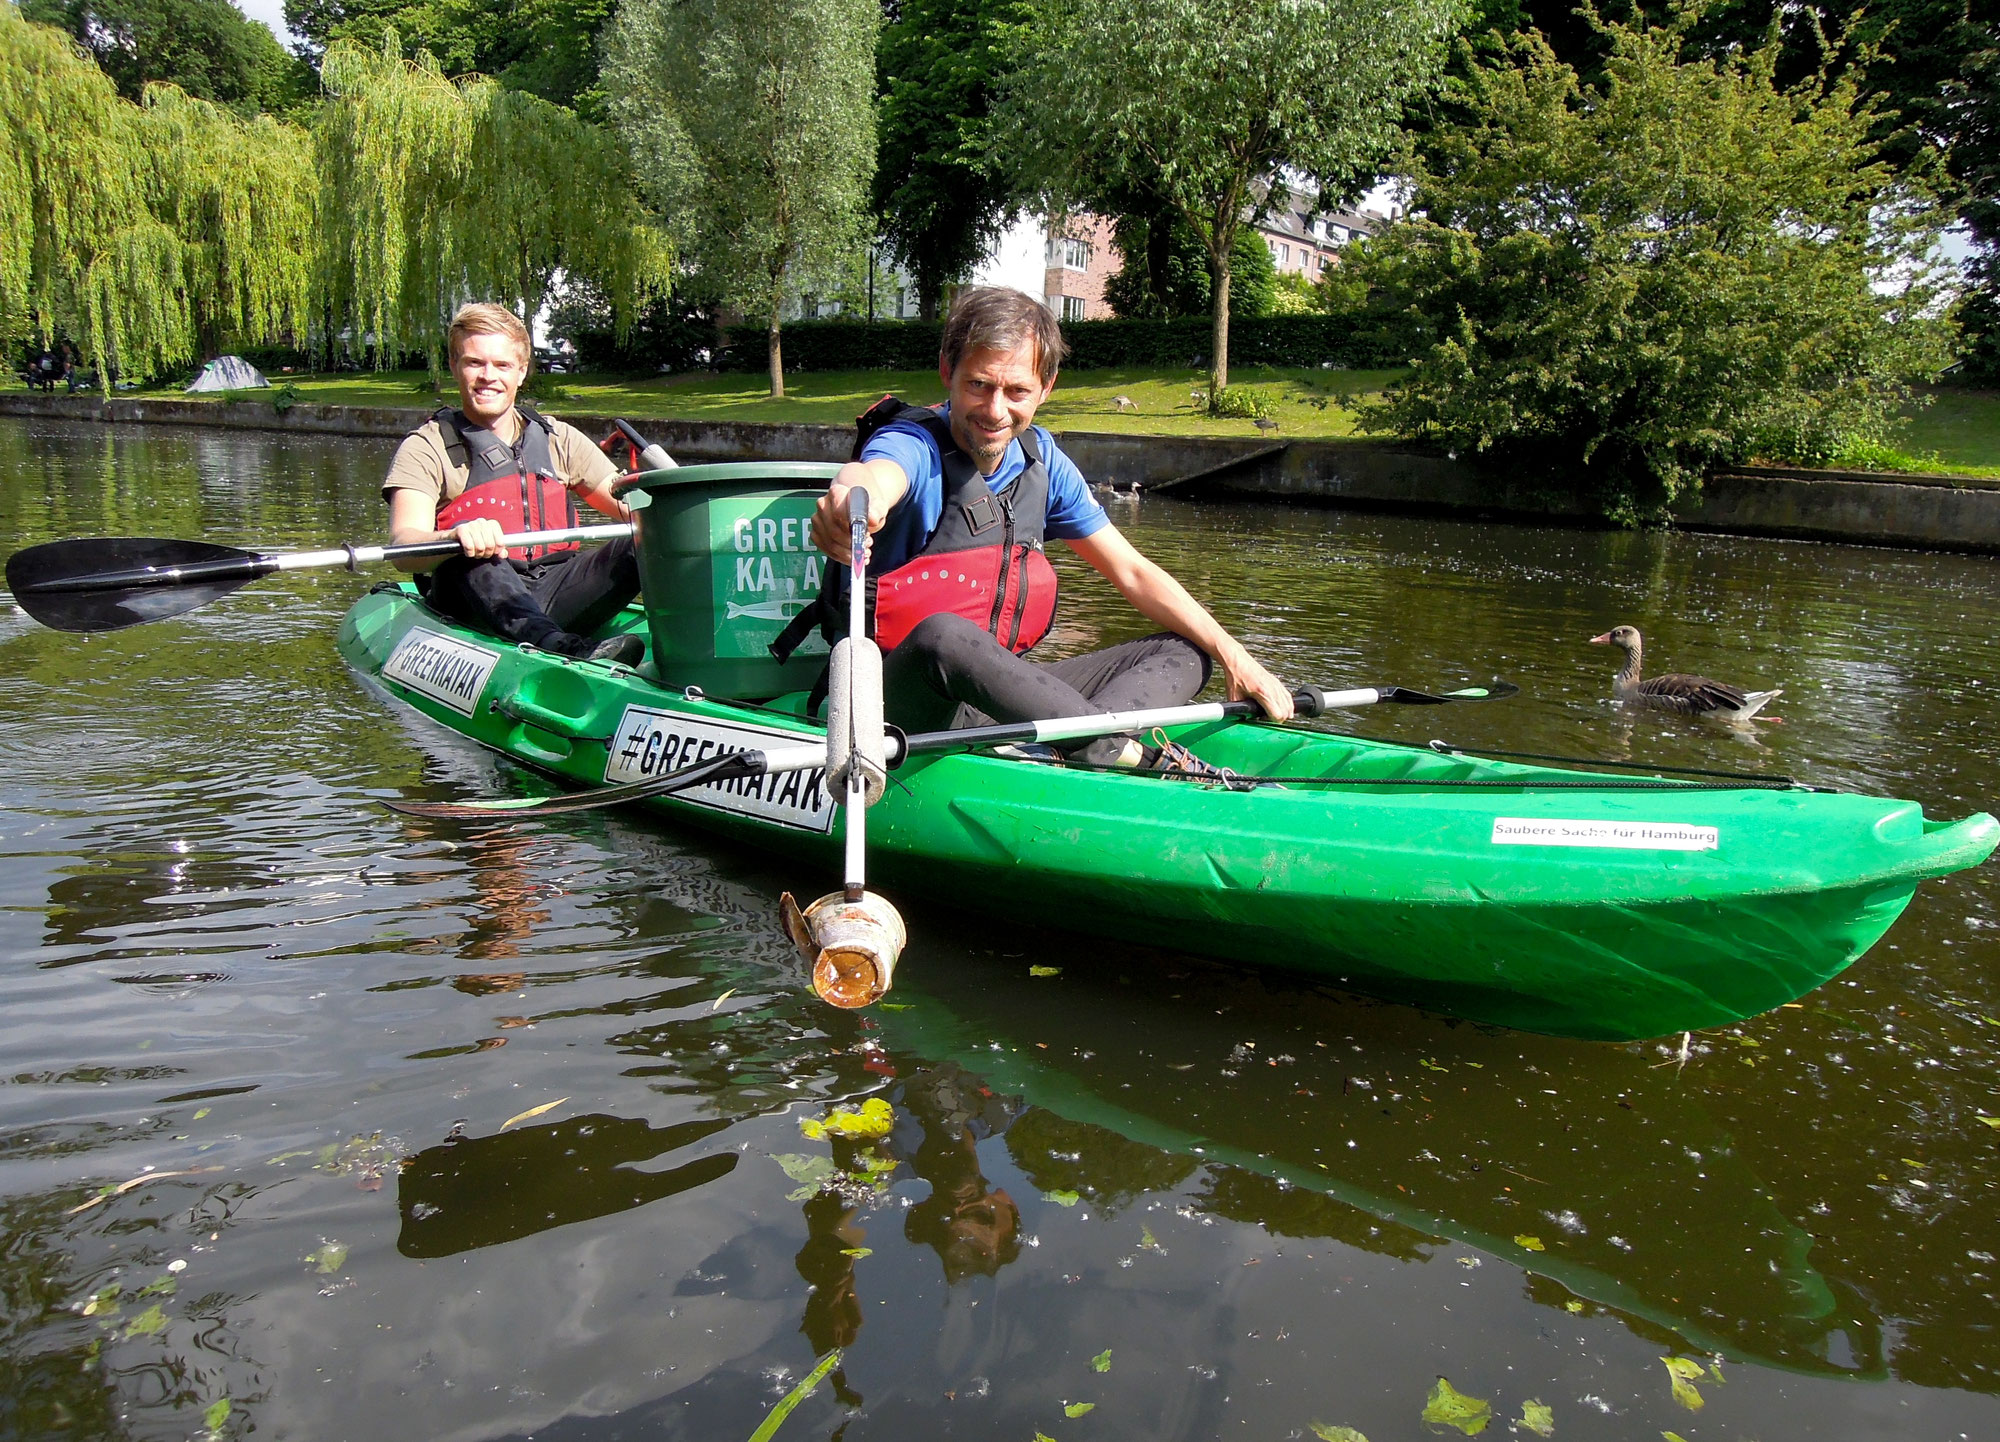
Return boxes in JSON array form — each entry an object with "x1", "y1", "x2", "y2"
[{"x1": 384, "y1": 680, "x2": 1520, "y2": 822}]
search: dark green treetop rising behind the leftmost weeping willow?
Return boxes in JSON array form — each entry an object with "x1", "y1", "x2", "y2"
[{"x1": 20, "y1": 0, "x2": 314, "y2": 110}]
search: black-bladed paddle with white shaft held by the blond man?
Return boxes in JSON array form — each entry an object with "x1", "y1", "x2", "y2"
[{"x1": 6, "y1": 524, "x2": 632, "y2": 632}]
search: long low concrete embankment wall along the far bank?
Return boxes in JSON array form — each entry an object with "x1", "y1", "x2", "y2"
[{"x1": 0, "y1": 392, "x2": 2000, "y2": 554}]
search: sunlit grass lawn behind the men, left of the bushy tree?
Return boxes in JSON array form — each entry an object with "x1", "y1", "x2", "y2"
[{"x1": 136, "y1": 366, "x2": 1400, "y2": 438}]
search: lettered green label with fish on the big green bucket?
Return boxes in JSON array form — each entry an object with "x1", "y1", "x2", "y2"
[{"x1": 708, "y1": 496, "x2": 826, "y2": 658}]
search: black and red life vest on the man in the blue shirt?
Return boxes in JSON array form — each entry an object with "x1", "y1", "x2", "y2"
[{"x1": 770, "y1": 396, "x2": 1056, "y2": 660}]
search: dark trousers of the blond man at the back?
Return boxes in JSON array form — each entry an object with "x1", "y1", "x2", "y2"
[{"x1": 424, "y1": 536, "x2": 638, "y2": 656}]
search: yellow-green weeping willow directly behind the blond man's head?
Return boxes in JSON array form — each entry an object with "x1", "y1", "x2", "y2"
[{"x1": 314, "y1": 34, "x2": 668, "y2": 370}]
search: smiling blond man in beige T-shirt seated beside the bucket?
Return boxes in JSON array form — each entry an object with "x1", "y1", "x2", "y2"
[{"x1": 382, "y1": 304, "x2": 646, "y2": 666}]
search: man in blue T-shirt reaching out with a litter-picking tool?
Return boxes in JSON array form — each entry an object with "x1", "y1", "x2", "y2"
[{"x1": 812, "y1": 286, "x2": 1292, "y2": 766}]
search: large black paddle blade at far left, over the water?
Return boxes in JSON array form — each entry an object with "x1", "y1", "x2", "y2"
[{"x1": 6, "y1": 536, "x2": 268, "y2": 632}]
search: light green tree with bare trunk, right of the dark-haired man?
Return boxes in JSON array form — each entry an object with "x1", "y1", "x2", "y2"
[{"x1": 994, "y1": 0, "x2": 1460, "y2": 398}]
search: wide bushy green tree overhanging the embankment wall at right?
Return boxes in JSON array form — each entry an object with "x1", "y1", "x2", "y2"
[{"x1": 1354, "y1": 26, "x2": 1944, "y2": 520}]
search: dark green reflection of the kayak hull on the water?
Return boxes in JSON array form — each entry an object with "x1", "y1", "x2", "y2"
[{"x1": 882, "y1": 952, "x2": 1884, "y2": 1376}]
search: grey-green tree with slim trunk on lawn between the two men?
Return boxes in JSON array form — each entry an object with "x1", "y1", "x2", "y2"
[{"x1": 604, "y1": 0, "x2": 882, "y2": 396}]
